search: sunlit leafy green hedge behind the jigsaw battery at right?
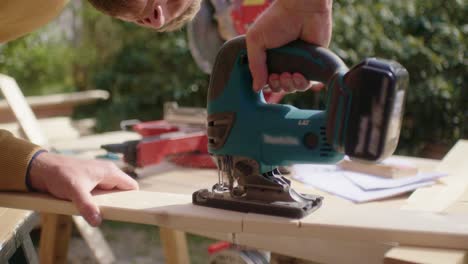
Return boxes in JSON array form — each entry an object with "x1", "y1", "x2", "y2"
[{"x1": 292, "y1": 0, "x2": 468, "y2": 155}]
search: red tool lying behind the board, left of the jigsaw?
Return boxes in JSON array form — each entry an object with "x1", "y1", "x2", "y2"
[{"x1": 101, "y1": 92, "x2": 285, "y2": 174}]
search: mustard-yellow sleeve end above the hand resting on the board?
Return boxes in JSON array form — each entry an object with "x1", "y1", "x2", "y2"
[{"x1": 0, "y1": 130, "x2": 41, "y2": 191}]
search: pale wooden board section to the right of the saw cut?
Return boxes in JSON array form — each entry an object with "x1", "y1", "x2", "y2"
[{"x1": 243, "y1": 205, "x2": 468, "y2": 249}]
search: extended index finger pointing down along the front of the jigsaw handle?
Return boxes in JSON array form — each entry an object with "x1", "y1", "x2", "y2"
[{"x1": 246, "y1": 33, "x2": 268, "y2": 92}]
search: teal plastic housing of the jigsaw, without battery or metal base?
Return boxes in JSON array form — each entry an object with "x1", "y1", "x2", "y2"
[{"x1": 208, "y1": 47, "x2": 344, "y2": 172}]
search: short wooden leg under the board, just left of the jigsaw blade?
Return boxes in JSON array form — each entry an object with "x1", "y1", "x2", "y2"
[{"x1": 159, "y1": 227, "x2": 190, "y2": 264}]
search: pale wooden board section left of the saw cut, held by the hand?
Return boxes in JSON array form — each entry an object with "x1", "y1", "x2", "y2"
[{"x1": 0, "y1": 191, "x2": 244, "y2": 232}]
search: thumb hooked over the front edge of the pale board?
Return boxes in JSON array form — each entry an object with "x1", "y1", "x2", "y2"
[{"x1": 72, "y1": 190, "x2": 102, "y2": 226}]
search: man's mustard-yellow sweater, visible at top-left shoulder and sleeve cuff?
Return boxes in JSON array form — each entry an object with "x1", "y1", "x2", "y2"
[{"x1": 0, "y1": 0, "x2": 67, "y2": 191}]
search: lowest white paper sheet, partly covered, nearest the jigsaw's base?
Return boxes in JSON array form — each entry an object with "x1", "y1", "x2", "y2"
[{"x1": 293, "y1": 164, "x2": 435, "y2": 203}]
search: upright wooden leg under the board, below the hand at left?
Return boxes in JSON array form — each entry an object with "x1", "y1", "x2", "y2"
[{"x1": 39, "y1": 213, "x2": 73, "y2": 264}]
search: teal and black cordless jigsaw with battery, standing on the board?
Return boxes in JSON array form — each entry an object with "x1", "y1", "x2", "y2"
[{"x1": 192, "y1": 36, "x2": 409, "y2": 218}]
